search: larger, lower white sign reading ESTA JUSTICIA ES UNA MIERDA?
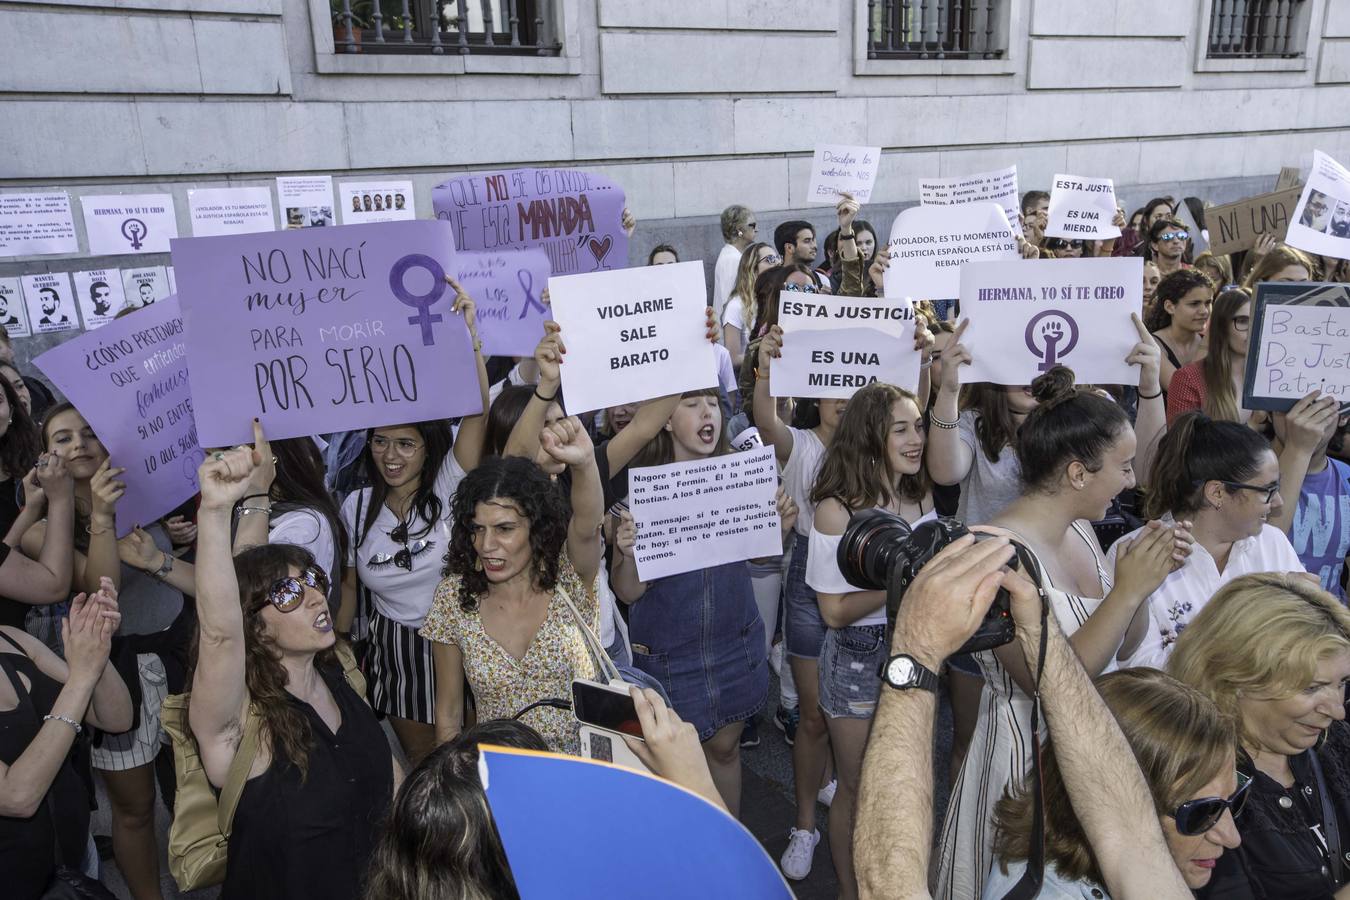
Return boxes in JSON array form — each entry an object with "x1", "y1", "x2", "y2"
[{"x1": 768, "y1": 291, "x2": 921, "y2": 399}]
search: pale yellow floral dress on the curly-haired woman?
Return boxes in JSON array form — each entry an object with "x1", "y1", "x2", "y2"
[{"x1": 420, "y1": 551, "x2": 599, "y2": 756}]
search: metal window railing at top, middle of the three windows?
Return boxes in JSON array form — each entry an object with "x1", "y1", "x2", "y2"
[{"x1": 867, "y1": 0, "x2": 1008, "y2": 59}]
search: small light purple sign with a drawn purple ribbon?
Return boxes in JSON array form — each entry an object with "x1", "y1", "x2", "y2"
[{"x1": 455, "y1": 248, "x2": 552, "y2": 356}]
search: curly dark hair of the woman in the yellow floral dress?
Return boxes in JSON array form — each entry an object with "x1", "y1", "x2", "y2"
[{"x1": 441, "y1": 456, "x2": 572, "y2": 613}]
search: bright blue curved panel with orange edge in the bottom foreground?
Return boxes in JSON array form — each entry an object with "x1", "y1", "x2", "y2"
[{"x1": 478, "y1": 745, "x2": 792, "y2": 900}]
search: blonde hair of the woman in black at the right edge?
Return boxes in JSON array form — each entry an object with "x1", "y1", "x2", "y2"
[{"x1": 1168, "y1": 572, "x2": 1350, "y2": 739}]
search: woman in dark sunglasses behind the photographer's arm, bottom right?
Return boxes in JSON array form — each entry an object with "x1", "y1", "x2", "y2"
[{"x1": 983, "y1": 669, "x2": 1236, "y2": 900}]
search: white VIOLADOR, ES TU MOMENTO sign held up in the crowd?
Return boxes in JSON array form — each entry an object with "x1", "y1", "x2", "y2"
[{"x1": 884, "y1": 202, "x2": 1022, "y2": 300}]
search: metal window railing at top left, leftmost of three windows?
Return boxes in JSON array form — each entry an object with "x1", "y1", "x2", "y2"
[{"x1": 329, "y1": 0, "x2": 562, "y2": 57}]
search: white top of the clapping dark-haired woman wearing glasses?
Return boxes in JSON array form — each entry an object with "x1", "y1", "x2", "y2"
[{"x1": 1106, "y1": 514, "x2": 1304, "y2": 669}]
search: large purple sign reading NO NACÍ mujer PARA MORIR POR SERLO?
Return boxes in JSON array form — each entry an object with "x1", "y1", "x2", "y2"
[{"x1": 173, "y1": 221, "x2": 482, "y2": 447}]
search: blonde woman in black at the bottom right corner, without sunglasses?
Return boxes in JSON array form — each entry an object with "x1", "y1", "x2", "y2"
[{"x1": 1168, "y1": 573, "x2": 1350, "y2": 900}]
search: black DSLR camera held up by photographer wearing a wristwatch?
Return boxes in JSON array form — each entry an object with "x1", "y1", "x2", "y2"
[{"x1": 838, "y1": 509, "x2": 1041, "y2": 653}]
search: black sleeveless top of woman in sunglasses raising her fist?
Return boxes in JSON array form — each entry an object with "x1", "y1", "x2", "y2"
[{"x1": 220, "y1": 669, "x2": 394, "y2": 900}]
